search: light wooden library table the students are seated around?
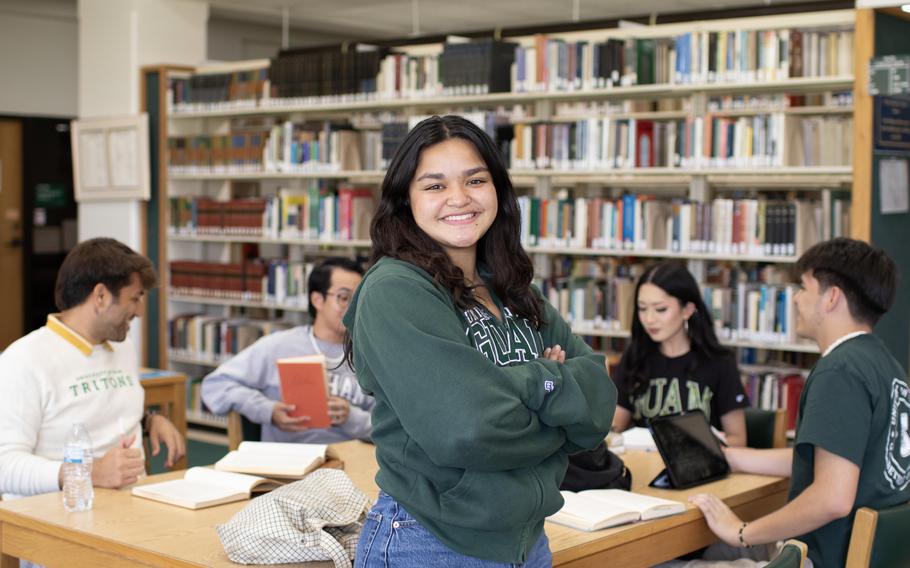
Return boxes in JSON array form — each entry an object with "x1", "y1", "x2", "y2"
[{"x1": 0, "y1": 442, "x2": 787, "y2": 568}]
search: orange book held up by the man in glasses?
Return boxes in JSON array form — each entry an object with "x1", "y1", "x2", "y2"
[{"x1": 278, "y1": 355, "x2": 331, "y2": 428}]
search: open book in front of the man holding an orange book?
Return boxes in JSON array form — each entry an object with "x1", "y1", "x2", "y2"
[{"x1": 215, "y1": 442, "x2": 328, "y2": 478}]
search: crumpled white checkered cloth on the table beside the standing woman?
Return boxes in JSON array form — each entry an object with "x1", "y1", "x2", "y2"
[{"x1": 216, "y1": 469, "x2": 370, "y2": 568}]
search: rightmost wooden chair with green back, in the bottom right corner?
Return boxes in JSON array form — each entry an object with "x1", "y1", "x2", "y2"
[{"x1": 847, "y1": 502, "x2": 910, "y2": 568}]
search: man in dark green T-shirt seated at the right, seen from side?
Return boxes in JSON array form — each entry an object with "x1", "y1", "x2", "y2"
[{"x1": 692, "y1": 238, "x2": 910, "y2": 567}]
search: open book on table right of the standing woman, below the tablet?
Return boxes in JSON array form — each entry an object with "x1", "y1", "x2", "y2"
[{"x1": 547, "y1": 489, "x2": 686, "y2": 531}]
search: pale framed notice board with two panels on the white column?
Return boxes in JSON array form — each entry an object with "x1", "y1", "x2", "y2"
[{"x1": 70, "y1": 113, "x2": 149, "y2": 201}]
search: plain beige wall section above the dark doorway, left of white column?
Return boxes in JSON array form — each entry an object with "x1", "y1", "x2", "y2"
[{"x1": 0, "y1": 0, "x2": 79, "y2": 116}]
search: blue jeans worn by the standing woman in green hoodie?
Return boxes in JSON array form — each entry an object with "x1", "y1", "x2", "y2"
[{"x1": 354, "y1": 492, "x2": 553, "y2": 568}]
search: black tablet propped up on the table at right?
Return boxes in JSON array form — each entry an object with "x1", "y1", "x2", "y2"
[{"x1": 649, "y1": 410, "x2": 730, "y2": 489}]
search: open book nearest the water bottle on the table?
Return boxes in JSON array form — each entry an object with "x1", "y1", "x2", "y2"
[{"x1": 133, "y1": 467, "x2": 281, "y2": 509}]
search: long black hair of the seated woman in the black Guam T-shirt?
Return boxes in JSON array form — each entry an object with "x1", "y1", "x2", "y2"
[{"x1": 622, "y1": 262, "x2": 732, "y2": 398}]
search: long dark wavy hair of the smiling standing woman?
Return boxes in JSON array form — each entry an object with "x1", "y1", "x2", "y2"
[{"x1": 345, "y1": 115, "x2": 546, "y2": 368}]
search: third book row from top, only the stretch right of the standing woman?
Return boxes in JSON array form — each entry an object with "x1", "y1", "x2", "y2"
[{"x1": 518, "y1": 193, "x2": 850, "y2": 260}]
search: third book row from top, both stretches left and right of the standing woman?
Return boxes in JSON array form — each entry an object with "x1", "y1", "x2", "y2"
[{"x1": 169, "y1": 191, "x2": 850, "y2": 260}]
